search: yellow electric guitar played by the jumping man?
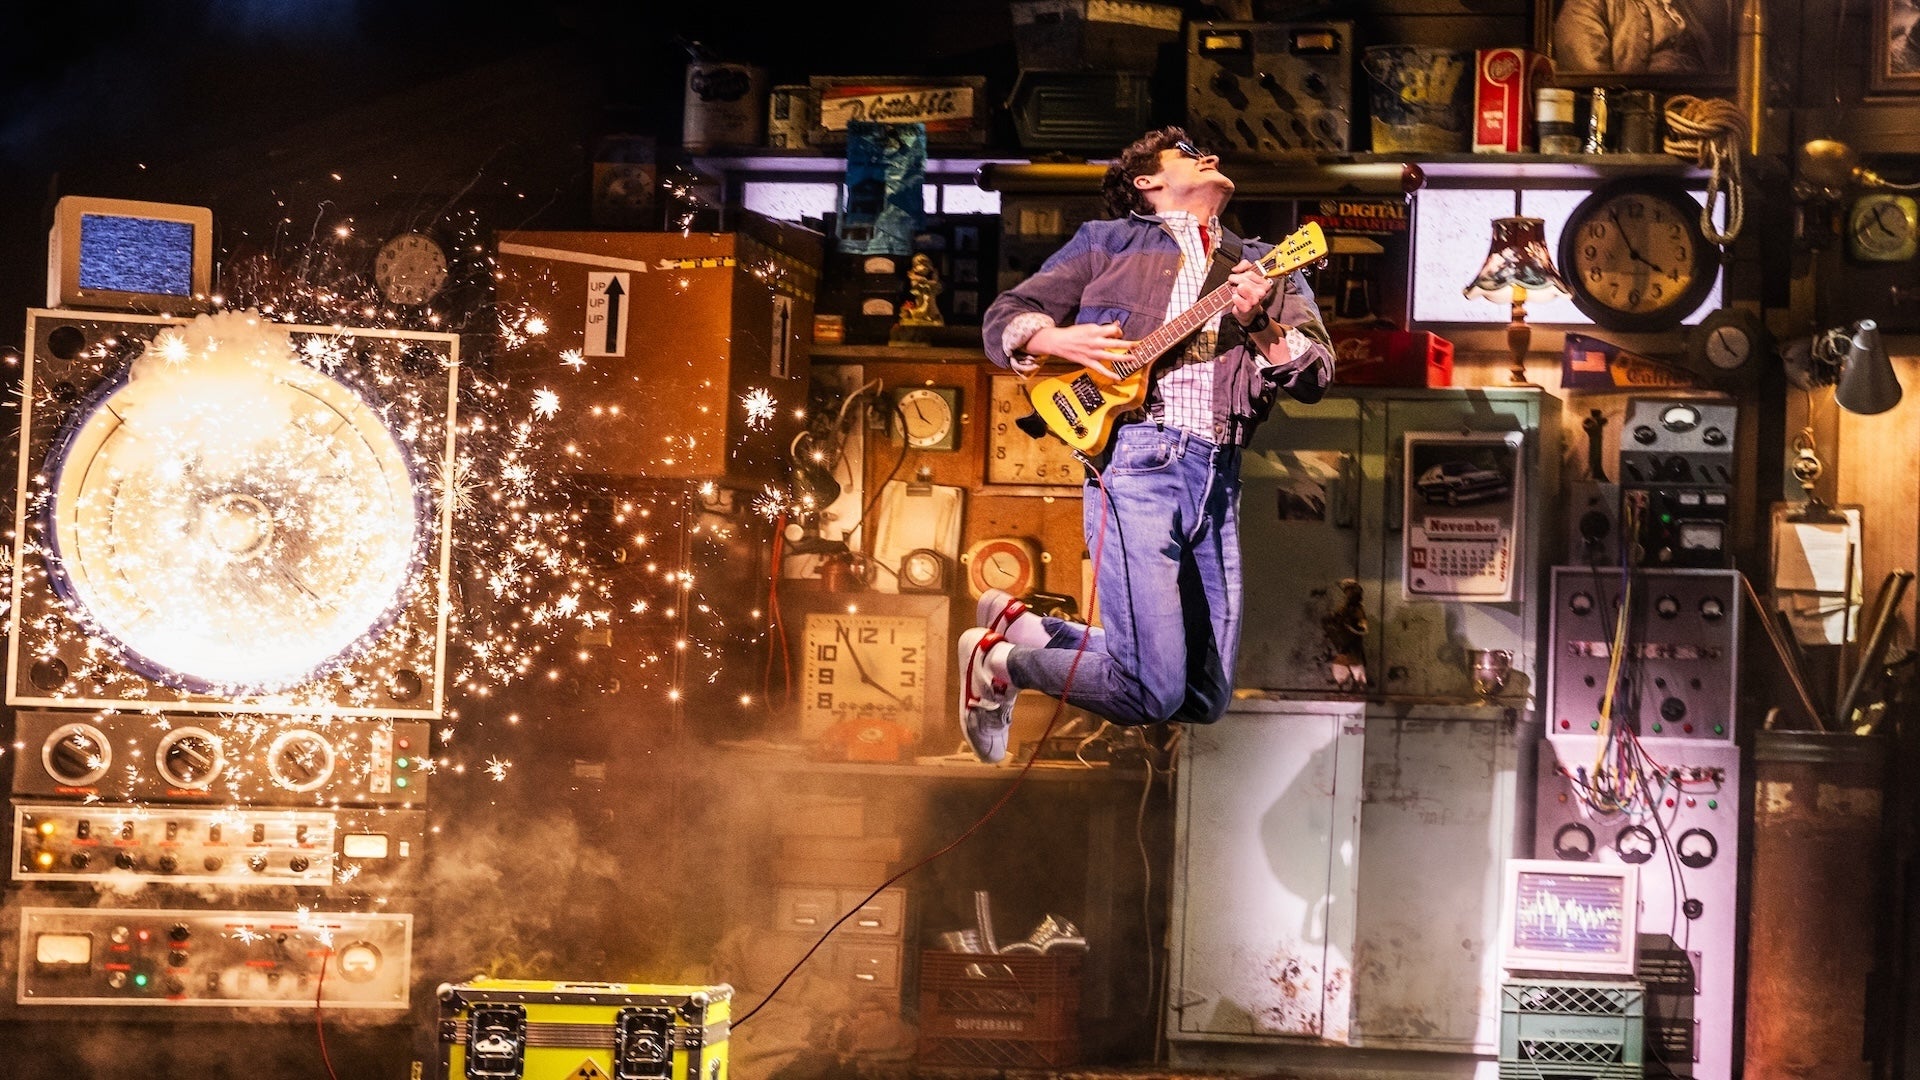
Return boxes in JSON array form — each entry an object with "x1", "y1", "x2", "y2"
[{"x1": 1027, "y1": 221, "x2": 1327, "y2": 455}]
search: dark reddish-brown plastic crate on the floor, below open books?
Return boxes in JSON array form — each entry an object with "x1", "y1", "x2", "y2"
[{"x1": 918, "y1": 949, "x2": 1081, "y2": 1068}]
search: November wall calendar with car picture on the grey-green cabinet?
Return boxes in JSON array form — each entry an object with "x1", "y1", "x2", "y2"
[{"x1": 1400, "y1": 430, "x2": 1526, "y2": 603}]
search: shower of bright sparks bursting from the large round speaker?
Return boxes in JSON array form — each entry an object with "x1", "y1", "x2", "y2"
[{"x1": 0, "y1": 184, "x2": 803, "y2": 807}]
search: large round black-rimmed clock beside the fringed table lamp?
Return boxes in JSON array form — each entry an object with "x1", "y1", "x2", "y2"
[{"x1": 1559, "y1": 177, "x2": 1720, "y2": 331}]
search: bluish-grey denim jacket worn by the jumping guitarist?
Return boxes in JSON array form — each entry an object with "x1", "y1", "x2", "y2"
[{"x1": 981, "y1": 213, "x2": 1332, "y2": 446}]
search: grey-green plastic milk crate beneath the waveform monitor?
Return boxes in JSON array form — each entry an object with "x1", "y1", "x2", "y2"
[{"x1": 1500, "y1": 978, "x2": 1647, "y2": 1080}]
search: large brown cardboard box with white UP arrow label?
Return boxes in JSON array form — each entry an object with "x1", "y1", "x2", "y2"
[{"x1": 495, "y1": 213, "x2": 824, "y2": 478}]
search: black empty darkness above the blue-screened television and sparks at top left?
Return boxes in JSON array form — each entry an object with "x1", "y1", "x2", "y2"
[{"x1": 0, "y1": 0, "x2": 1044, "y2": 336}]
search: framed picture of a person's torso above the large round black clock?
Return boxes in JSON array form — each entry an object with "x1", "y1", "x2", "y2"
[{"x1": 1534, "y1": 0, "x2": 1735, "y2": 90}]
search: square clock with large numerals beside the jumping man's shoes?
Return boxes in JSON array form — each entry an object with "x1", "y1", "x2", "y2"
[{"x1": 797, "y1": 592, "x2": 952, "y2": 738}]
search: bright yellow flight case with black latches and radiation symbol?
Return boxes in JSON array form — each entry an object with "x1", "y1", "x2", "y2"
[{"x1": 440, "y1": 978, "x2": 733, "y2": 1080}]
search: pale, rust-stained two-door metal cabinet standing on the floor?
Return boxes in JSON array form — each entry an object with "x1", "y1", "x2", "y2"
[{"x1": 1165, "y1": 698, "x2": 1536, "y2": 1065}]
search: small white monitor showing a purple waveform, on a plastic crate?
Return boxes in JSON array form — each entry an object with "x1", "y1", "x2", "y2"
[{"x1": 1500, "y1": 859, "x2": 1640, "y2": 976}]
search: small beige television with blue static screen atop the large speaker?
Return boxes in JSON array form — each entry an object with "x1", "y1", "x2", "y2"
[{"x1": 48, "y1": 196, "x2": 213, "y2": 313}]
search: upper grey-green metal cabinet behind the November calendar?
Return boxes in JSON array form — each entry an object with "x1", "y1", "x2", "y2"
[{"x1": 1236, "y1": 388, "x2": 1559, "y2": 701}]
